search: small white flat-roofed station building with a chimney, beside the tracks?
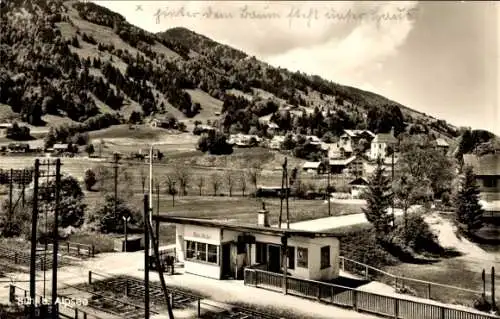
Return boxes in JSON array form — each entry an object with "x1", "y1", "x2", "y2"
[{"x1": 153, "y1": 207, "x2": 339, "y2": 280}]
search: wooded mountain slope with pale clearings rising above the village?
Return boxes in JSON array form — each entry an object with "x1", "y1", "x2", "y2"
[{"x1": 0, "y1": 0, "x2": 457, "y2": 139}]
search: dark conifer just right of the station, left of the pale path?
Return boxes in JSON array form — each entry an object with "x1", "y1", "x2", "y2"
[{"x1": 363, "y1": 158, "x2": 393, "y2": 236}]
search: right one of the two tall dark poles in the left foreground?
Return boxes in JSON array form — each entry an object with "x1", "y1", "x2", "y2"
[{"x1": 51, "y1": 158, "x2": 61, "y2": 319}]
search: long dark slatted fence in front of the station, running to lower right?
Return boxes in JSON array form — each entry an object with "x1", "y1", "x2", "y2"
[{"x1": 245, "y1": 268, "x2": 500, "y2": 319}]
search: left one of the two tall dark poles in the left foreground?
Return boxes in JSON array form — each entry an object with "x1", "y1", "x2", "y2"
[{"x1": 30, "y1": 159, "x2": 40, "y2": 318}]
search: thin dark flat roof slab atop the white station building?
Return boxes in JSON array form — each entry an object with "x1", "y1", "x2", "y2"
[{"x1": 153, "y1": 214, "x2": 337, "y2": 238}]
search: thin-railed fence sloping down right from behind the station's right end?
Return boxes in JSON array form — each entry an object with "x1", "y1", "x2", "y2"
[{"x1": 339, "y1": 256, "x2": 488, "y2": 301}]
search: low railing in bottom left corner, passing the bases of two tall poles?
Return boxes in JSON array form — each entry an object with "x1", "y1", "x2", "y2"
[{"x1": 9, "y1": 284, "x2": 102, "y2": 319}]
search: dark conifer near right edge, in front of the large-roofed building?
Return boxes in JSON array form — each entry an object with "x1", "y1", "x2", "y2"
[{"x1": 456, "y1": 166, "x2": 483, "y2": 233}]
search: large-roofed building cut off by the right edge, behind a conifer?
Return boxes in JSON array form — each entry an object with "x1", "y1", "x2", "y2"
[{"x1": 463, "y1": 154, "x2": 500, "y2": 201}]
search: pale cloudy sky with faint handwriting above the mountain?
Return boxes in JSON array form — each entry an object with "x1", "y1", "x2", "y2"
[{"x1": 93, "y1": 1, "x2": 500, "y2": 135}]
